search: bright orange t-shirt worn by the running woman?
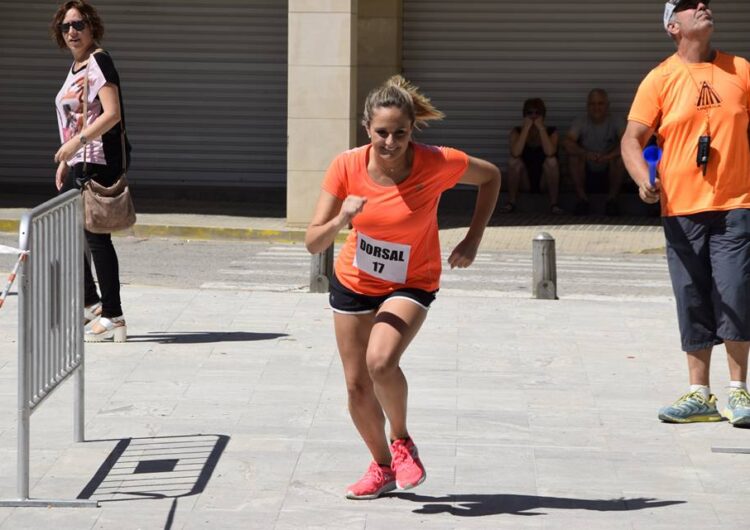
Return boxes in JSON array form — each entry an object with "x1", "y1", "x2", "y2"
[{"x1": 322, "y1": 143, "x2": 469, "y2": 296}]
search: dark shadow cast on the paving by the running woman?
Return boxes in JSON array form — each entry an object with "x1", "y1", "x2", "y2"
[{"x1": 389, "y1": 493, "x2": 686, "y2": 517}]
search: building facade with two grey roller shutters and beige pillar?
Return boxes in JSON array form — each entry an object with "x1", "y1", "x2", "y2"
[{"x1": 0, "y1": 0, "x2": 750, "y2": 225}]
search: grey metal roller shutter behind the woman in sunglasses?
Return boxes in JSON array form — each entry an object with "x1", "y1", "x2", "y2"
[{"x1": 0, "y1": 0, "x2": 287, "y2": 187}]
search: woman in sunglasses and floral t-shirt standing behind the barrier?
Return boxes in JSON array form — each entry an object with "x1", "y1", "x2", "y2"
[{"x1": 50, "y1": 0, "x2": 130, "y2": 342}]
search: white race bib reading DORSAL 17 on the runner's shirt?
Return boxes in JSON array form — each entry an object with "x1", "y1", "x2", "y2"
[{"x1": 353, "y1": 232, "x2": 411, "y2": 283}]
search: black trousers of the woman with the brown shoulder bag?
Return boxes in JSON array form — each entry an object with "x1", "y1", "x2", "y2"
[{"x1": 60, "y1": 164, "x2": 122, "y2": 318}]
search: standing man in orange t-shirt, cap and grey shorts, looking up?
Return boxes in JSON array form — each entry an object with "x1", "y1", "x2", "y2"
[{"x1": 621, "y1": 0, "x2": 750, "y2": 420}]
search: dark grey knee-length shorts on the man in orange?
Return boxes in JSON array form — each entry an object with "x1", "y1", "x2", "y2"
[{"x1": 662, "y1": 208, "x2": 750, "y2": 352}]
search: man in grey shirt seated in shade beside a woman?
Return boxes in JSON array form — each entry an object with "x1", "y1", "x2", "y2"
[{"x1": 563, "y1": 88, "x2": 625, "y2": 215}]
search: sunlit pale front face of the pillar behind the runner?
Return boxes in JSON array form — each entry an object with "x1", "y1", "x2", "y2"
[{"x1": 287, "y1": 0, "x2": 357, "y2": 226}]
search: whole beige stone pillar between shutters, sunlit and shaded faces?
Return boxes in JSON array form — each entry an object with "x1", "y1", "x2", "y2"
[{"x1": 287, "y1": 0, "x2": 402, "y2": 226}]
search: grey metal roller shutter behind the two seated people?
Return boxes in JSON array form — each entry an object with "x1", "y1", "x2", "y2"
[{"x1": 403, "y1": 0, "x2": 750, "y2": 173}]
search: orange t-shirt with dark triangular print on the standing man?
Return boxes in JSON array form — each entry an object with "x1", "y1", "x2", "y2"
[{"x1": 628, "y1": 52, "x2": 750, "y2": 216}]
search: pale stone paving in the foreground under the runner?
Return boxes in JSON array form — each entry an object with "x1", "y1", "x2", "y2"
[{"x1": 0, "y1": 278, "x2": 750, "y2": 530}]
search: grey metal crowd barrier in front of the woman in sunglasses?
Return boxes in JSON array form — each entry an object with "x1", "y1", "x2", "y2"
[{"x1": 0, "y1": 190, "x2": 98, "y2": 507}]
